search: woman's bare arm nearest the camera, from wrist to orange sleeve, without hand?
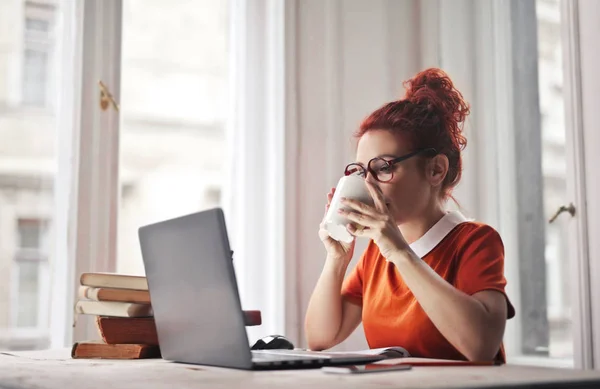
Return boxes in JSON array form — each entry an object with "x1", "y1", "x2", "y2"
[{"x1": 388, "y1": 249, "x2": 507, "y2": 361}]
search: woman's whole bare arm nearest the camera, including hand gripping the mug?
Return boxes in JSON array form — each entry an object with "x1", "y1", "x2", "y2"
[{"x1": 341, "y1": 181, "x2": 508, "y2": 360}]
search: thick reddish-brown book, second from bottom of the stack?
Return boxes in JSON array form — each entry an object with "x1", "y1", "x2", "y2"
[{"x1": 96, "y1": 316, "x2": 158, "y2": 346}]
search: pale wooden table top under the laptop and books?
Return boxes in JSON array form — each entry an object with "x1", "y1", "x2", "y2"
[{"x1": 0, "y1": 349, "x2": 600, "y2": 389}]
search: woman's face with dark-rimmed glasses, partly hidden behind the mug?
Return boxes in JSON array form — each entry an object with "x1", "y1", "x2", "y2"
[{"x1": 356, "y1": 130, "x2": 437, "y2": 224}]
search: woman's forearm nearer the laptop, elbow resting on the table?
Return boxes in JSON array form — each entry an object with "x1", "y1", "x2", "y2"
[{"x1": 305, "y1": 257, "x2": 362, "y2": 350}]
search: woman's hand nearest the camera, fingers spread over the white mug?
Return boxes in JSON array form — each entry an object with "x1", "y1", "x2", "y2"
[{"x1": 339, "y1": 181, "x2": 409, "y2": 261}]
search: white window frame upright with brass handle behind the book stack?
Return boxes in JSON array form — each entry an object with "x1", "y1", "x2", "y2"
[{"x1": 51, "y1": 0, "x2": 122, "y2": 347}]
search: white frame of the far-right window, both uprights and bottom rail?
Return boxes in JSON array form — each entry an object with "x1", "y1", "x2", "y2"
[{"x1": 480, "y1": 0, "x2": 594, "y2": 369}]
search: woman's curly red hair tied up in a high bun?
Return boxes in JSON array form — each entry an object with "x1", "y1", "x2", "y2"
[{"x1": 356, "y1": 68, "x2": 469, "y2": 197}]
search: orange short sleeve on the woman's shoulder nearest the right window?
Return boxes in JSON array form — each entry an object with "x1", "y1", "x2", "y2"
[{"x1": 456, "y1": 225, "x2": 515, "y2": 319}]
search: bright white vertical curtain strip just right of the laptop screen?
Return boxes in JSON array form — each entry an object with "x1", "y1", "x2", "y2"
[{"x1": 223, "y1": 0, "x2": 288, "y2": 343}]
